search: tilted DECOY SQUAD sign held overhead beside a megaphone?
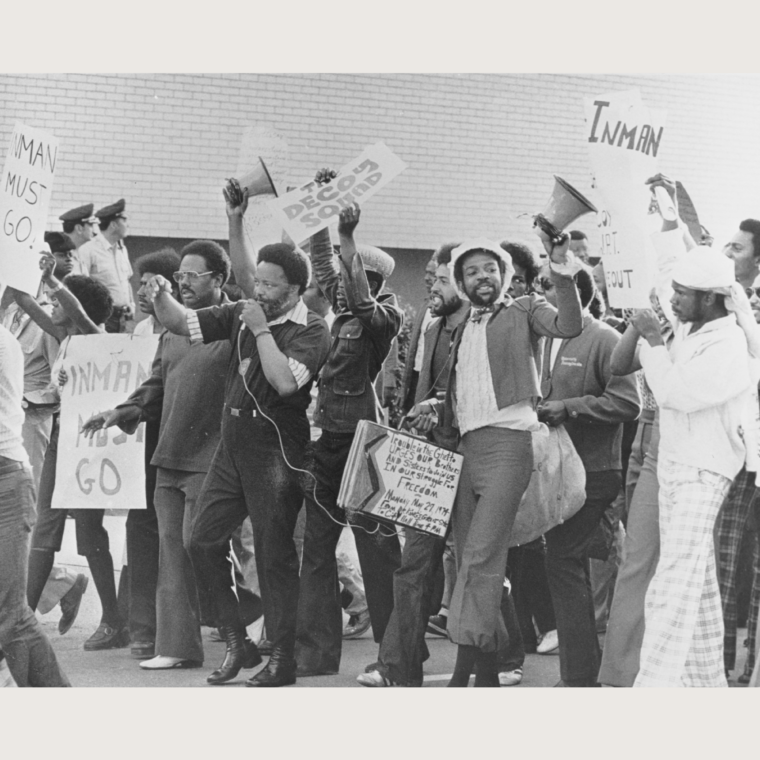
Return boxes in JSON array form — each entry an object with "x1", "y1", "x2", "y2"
[{"x1": 268, "y1": 142, "x2": 406, "y2": 243}]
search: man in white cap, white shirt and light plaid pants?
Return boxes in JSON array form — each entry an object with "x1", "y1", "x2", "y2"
[{"x1": 633, "y1": 247, "x2": 756, "y2": 686}]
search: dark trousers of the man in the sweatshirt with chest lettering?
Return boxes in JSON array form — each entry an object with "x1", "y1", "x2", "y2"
[{"x1": 546, "y1": 470, "x2": 622, "y2": 685}]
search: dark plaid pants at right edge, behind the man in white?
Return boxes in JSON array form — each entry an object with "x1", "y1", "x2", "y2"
[{"x1": 718, "y1": 468, "x2": 760, "y2": 671}]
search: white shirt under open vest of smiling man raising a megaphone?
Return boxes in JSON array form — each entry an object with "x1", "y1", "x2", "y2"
[{"x1": 456, "y1": 319, "x2": 538, "y2": 435}]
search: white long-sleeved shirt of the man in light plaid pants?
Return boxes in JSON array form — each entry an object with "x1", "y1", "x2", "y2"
[{"x1": 639, "y1": 314, "x2": 757, "y2": 479}]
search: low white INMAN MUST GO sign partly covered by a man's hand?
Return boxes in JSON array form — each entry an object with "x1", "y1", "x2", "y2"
[{"x1": 53, "y1": 334, "x2": 158, "y2": 509}]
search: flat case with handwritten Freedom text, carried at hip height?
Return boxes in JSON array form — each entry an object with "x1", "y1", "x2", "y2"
[{"x1": 338, "y1": 420, "x2": 462, "y2": 536}]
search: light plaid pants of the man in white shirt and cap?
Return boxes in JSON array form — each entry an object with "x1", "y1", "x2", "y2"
[{"x1": 633, "y1": 459, "x2": 731, "y2": 686}]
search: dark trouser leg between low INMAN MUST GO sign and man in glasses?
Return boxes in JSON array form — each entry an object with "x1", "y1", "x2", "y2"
[{"x1": 127, "y1": 422, "x2": 159, "y2": 641}]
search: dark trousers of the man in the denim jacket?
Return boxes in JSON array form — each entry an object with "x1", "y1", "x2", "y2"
[{"x1": 297, "y1": 430, "x2": 401, "y2": 673}]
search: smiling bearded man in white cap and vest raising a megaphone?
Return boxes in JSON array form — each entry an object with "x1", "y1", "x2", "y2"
[{"x1": 409, "y1": 230, "x2": 583, "y2": 687}]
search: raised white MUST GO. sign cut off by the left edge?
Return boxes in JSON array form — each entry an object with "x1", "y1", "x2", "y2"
[{"x1": 0, "y1": 123, "x2": 58, "y2": 294}]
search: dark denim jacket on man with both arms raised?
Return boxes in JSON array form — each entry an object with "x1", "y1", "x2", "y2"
[{"x1": 311, "y1": 230, "x2": 404, "y2": 433}]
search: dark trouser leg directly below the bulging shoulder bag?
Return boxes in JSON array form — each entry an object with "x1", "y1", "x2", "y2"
[{"x1": 507, "y1": 536, "x2": 557, "y2": 653}]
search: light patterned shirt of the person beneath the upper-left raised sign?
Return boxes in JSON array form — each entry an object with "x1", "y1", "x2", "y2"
[{"x1": 3, "y1": 296, "x2": 58, "y2": 404}]
